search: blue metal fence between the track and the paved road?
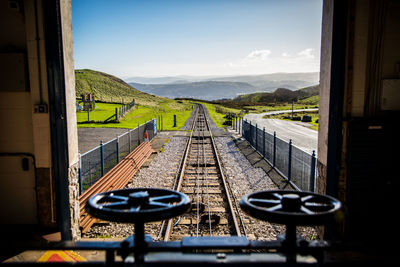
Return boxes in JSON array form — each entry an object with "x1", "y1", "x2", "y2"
[{"x1": 239, "y1": 120, "x2": 316, "y2": 192}]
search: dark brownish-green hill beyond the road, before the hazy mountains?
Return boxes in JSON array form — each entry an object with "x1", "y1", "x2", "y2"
[{"x1": 232, "y1": 85, "x2": 319, "y2": 103}]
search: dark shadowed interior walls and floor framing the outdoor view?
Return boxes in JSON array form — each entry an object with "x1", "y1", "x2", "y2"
[{"x1": 0, "y1": 0, "x2": 400, "y2": 266}]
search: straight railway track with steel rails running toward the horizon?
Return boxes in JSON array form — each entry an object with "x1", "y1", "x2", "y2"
[{"x1": 159, "y1": 105, "x2": 246, "y2": 241}]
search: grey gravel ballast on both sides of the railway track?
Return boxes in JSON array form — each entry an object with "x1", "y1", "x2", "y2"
[{"x1": 84, "y1": 137, "x2": 316, "y2": 240}]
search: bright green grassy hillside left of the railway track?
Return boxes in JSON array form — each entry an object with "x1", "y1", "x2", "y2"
[{"x1": 75, "y1": 69, "x2": 193, "y2": 130}]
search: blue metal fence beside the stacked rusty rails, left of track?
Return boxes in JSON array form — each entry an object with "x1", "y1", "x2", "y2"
[{"x1": 79, "y1": 119, "x2": 157, "y2": 193}]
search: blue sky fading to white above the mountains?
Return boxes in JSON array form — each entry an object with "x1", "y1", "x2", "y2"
[{"x1": 72, "y1": 0, "x2": 322, "y2": 78}]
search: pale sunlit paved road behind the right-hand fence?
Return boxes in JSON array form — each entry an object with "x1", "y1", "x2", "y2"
[{"x1": 244, "y1": 109, "x2": 318, "y2": 154}]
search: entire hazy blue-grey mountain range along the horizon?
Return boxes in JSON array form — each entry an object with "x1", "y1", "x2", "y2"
[{"x1": 125, "y1": 72, "x2": 319, "y2": 100}]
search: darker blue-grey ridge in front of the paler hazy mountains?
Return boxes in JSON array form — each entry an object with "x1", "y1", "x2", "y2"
[{"x1": 130, "y1": 81, "x2": 258, "y2": 100}]
